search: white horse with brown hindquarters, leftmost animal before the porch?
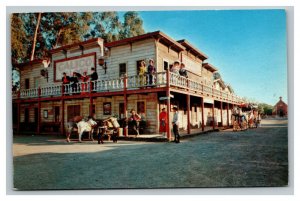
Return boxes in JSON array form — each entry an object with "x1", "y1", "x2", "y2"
[{"x1": 67, "y1": 118, "x2": 97, "y2": 142}]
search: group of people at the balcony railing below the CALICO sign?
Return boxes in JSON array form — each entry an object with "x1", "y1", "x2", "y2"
[{"x1": 62, "y1": 68, "x2": 98, "y2": 94}]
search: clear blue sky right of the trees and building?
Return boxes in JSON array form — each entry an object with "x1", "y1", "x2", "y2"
[{"x1": 129, "y1": 10, "x2": 287, "y2": 105}]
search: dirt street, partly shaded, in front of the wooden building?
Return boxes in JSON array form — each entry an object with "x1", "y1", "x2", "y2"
[{"x1": 13, "y1": 119, "x2": 288, "y2": 190}]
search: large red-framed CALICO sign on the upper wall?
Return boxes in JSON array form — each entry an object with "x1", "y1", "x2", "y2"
[{"x1": 54, "y1": 53, "x2": 96, "y2": 81}]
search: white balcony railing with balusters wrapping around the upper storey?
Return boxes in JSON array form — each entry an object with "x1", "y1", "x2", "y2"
[{"x1": 12, "y1": 72, "x2": 242, "y2": 103}]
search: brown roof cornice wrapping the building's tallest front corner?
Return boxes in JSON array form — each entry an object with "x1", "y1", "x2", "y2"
[{"x1": 104, "y1": 31, "x2": 185, "y2": 51}]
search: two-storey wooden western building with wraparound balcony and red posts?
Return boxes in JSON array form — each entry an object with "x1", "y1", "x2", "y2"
[{"x1": 13, "y1": 31, "x2": 242, "y2": 139}]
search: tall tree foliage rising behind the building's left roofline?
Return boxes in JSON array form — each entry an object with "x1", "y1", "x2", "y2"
[{"x1": 11, "y1": 11, "x2": 144, "y2": 64}]
